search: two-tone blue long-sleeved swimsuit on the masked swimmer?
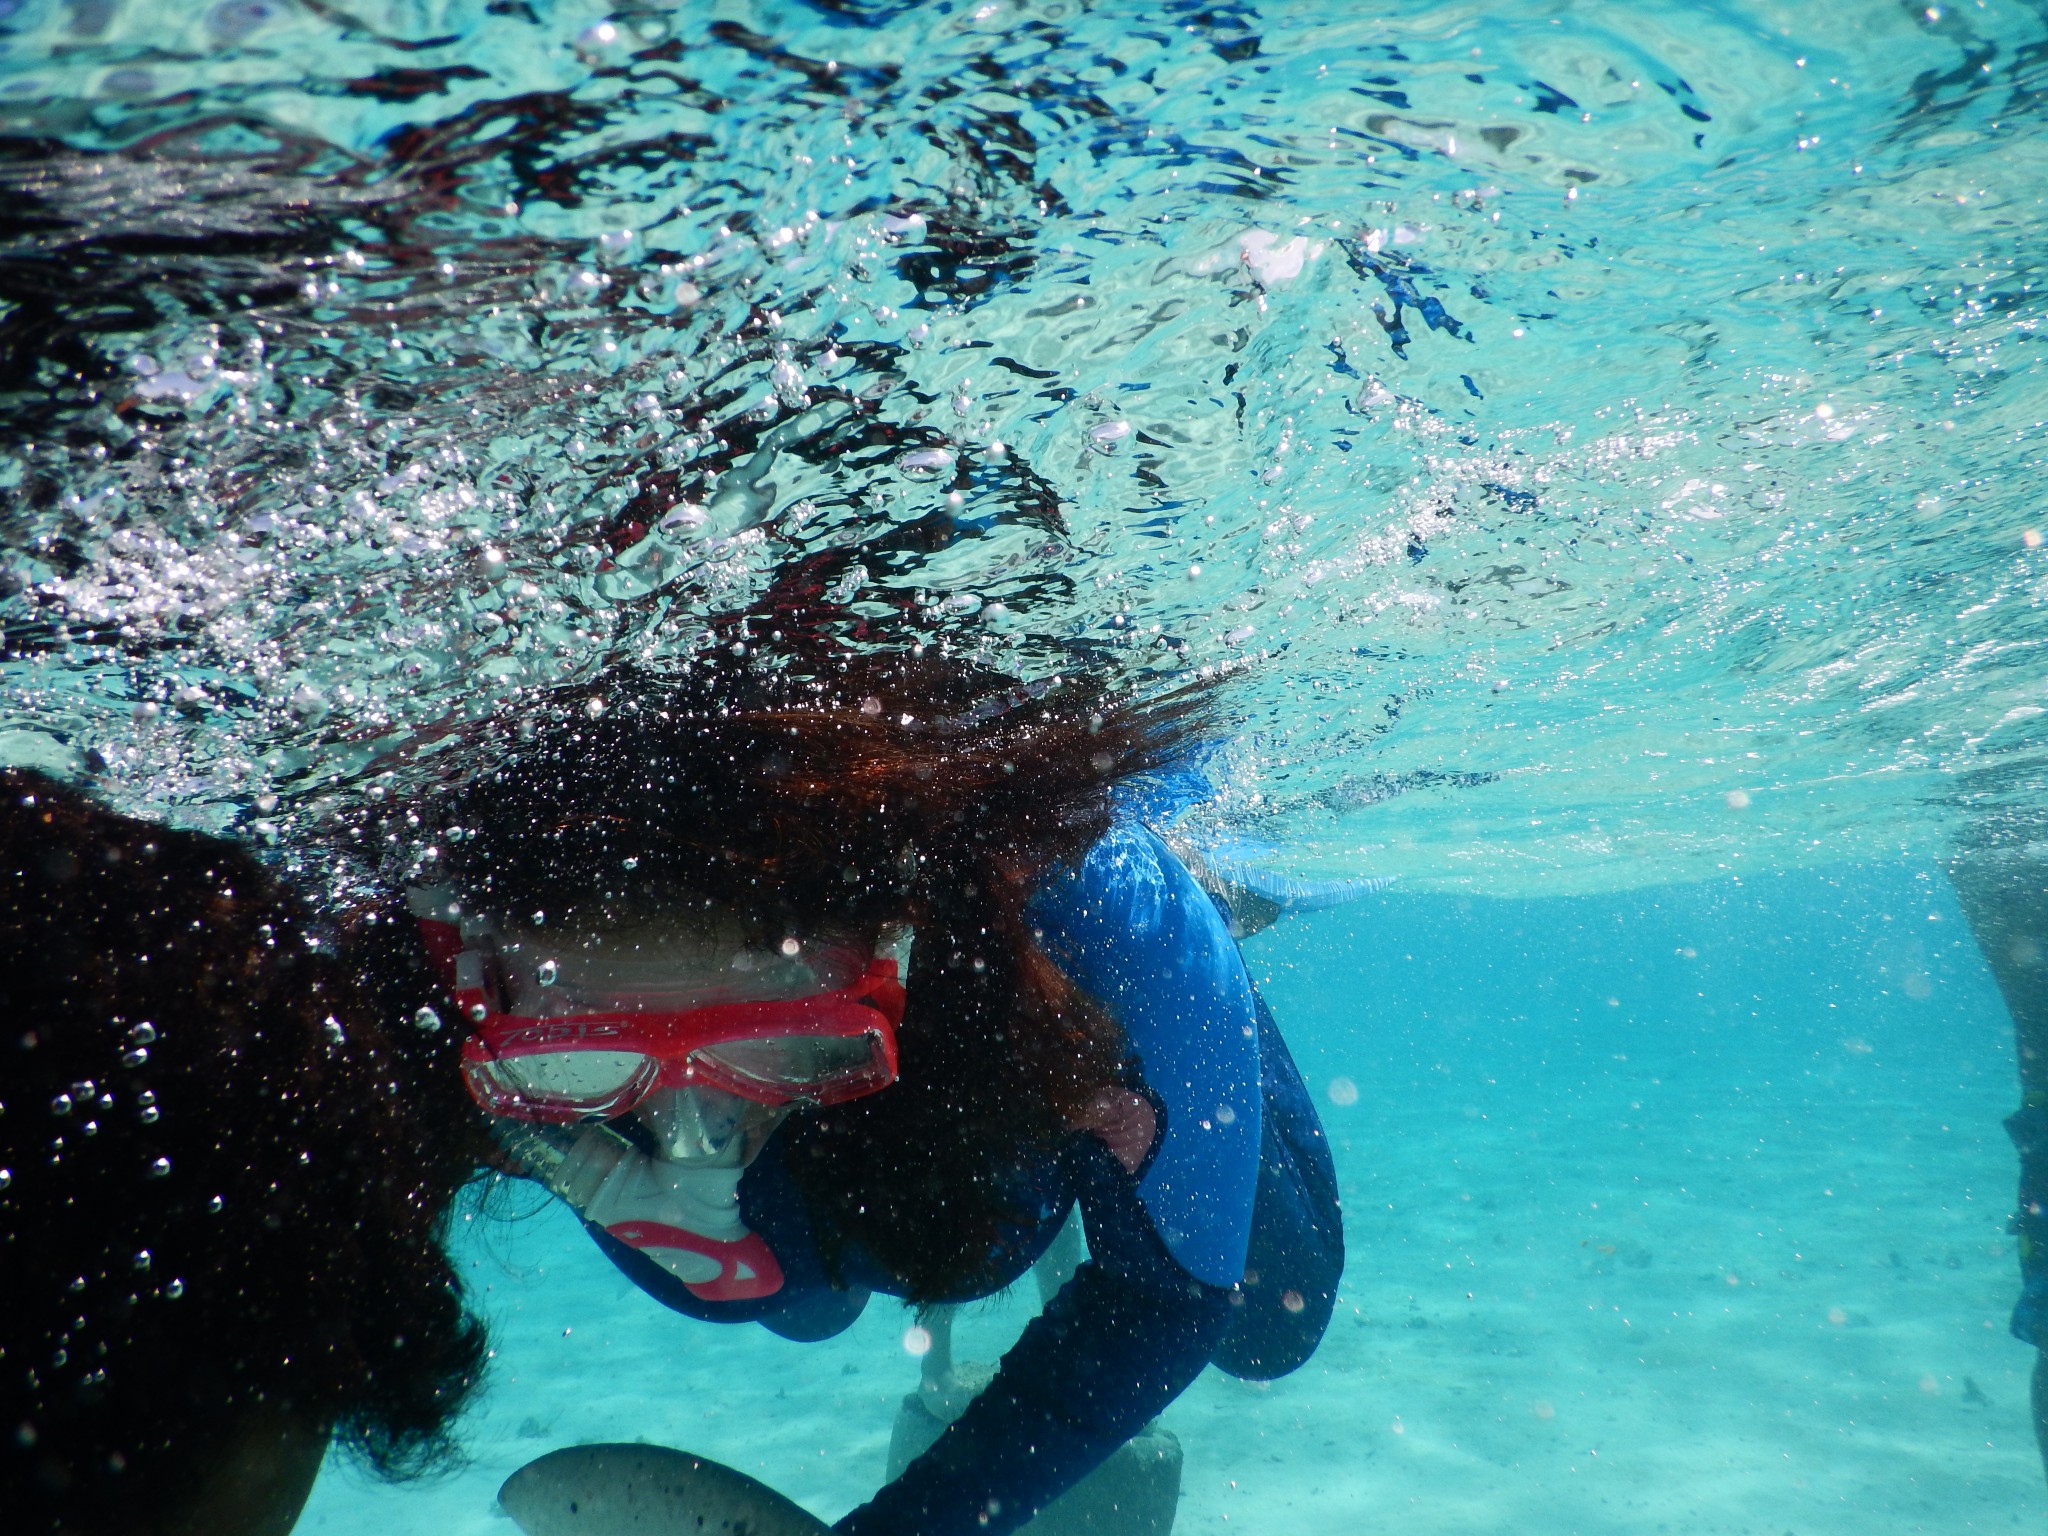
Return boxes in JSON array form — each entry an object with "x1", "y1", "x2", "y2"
[{"x1": 590, "y1": 821, "x2": 1343, "y2": 1536}]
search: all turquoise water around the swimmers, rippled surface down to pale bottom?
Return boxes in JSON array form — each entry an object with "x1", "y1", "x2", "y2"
[{"x1": 0, "y1": 0, "x2": 2048, "y2": 1534}]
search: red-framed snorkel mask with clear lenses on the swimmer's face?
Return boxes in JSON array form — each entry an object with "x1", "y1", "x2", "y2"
[{"x1": 412, "y1": 891, "x2": 903, "y2": 1124}]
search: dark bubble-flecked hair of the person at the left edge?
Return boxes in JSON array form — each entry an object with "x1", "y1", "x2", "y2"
[{"x1": 0, "y1": 770, "x2": 487, "y2": 1532}]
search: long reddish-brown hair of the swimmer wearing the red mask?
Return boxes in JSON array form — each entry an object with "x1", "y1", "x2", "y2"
[{"x1": 426, "y1": 649, "x2": 1206, "y2": 1300}]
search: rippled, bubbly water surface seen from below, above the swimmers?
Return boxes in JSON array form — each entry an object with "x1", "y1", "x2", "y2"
[{"x1": 0, "y1": 0, "x2": 2048, "y2": 891}]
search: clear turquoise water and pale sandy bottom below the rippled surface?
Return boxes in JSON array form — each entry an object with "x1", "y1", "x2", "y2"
[{"x1": 299, "y1": 868, "x2": 2048, "y2": 1536}]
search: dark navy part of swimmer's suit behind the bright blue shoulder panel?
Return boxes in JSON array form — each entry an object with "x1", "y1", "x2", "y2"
[{"x1": 1214, "y1": 997, "x2": 1343, "y2": 1380}]
